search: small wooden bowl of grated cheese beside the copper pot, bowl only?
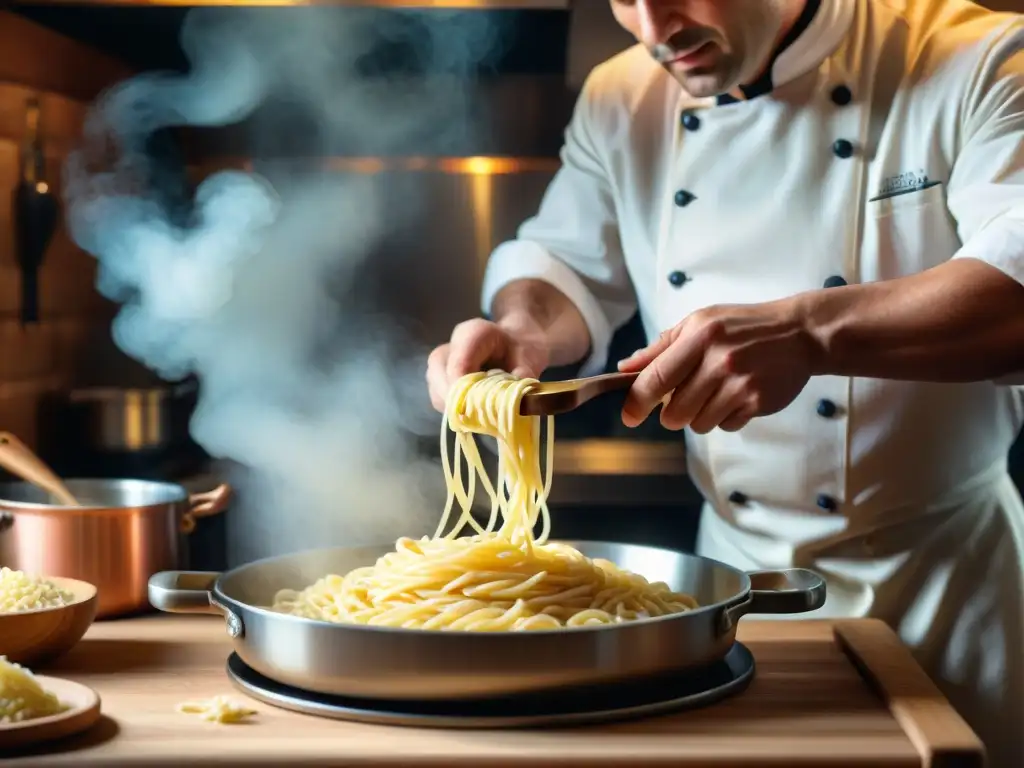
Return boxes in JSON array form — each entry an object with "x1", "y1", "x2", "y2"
[{"x1": 0, "y1": 577, "x2": 96, "y2": 668}]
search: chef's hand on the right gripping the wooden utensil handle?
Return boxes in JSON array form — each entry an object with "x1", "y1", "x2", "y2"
[{"x1": 618, "y1": 300, "x2": 815, "y2": 434}]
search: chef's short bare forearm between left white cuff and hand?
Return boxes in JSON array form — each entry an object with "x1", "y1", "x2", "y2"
[{"x1": 490, "y1": 280, "x2": 590, "y2": 367}]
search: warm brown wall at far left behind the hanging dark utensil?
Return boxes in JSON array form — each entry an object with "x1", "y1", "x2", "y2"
[{"x1": 0, "y1": 11, "x2": 131, "y2": 445}]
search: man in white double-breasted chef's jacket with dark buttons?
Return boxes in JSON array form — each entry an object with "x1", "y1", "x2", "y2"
[{"x1": 427, "y1": 0, "x2": 1024, "y2": 768}]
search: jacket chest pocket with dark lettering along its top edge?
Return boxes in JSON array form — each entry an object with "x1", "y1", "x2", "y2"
[{"x1": 861, "y1": 184, "x2": 961, "y2": 282}]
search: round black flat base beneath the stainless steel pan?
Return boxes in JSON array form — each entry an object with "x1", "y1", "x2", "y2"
[{"x1": 227, "y1": 643, "x2": 755, "y2": 728}]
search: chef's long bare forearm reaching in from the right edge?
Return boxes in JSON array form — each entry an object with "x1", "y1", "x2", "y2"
[{"x1": 793, "y1": 259, "x2": 1024, "y2": 382}]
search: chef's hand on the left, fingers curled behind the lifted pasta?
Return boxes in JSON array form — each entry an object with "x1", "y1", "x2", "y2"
[{"x1": 427, "y1": 317, "x2": 550, "y2": 413}]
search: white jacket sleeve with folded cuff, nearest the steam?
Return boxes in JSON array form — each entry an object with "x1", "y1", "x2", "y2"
[{"x1": 482, "y1": 76, "x2": 636, "y2": 376}]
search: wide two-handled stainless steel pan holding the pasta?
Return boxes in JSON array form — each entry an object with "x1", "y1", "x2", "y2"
[{"x1": 150, "y1": 542, "x2": 825, "y2": 700}]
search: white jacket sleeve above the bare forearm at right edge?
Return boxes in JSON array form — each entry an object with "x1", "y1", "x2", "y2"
[{"x1": 948, "y1": 19, "x2": 1024, "y2": 384}]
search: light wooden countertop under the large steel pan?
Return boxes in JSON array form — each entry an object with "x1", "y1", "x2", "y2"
[{"x1": 3, "y1": 615, "x2": 982, "y2": 768}]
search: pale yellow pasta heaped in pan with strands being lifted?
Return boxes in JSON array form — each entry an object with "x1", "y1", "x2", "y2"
[{"x1": 272, "y1": 372, "x2": 696, "y2": 632}]
